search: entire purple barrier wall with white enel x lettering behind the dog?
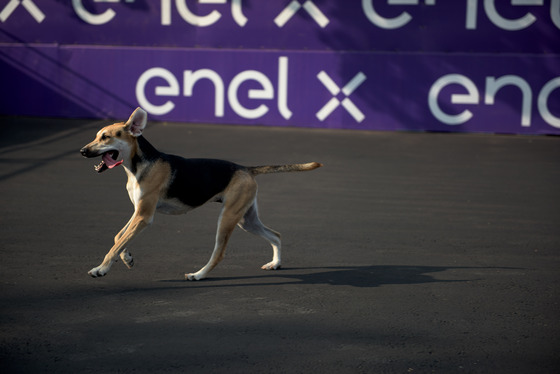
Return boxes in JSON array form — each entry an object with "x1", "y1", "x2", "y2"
[{"x1": 0, "y1": 0, "x2": 560, "y2": 134}]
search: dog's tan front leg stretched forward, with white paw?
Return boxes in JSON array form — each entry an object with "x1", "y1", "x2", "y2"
[{"x1": 88, "y1": 204, "x2": 155, "y2": 278}]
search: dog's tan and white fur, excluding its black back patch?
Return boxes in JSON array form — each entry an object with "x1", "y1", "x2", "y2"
[{"x1": 81, "y1": 108, "x2": 322, "y2": 280}]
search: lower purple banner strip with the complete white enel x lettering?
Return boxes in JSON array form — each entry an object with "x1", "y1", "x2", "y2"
[{"x1": 0, "y1": 46, "x2": 560, "y2": 134}]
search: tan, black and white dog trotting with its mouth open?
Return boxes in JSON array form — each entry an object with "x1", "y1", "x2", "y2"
[{"x1": 80, "y1": 108, "x2": 323, "y2": 280}]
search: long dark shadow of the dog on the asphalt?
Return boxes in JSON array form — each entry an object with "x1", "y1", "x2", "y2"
[{"x1": 161, "y1": 265, "x2": 506, "y2": 288}]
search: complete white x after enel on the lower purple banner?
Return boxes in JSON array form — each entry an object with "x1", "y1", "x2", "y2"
[{"x1": 316, "y1": 71, "x2": 366, "y2": 122}]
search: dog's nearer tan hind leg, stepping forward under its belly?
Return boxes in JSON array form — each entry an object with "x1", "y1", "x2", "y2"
[{"x1": 185, "y1": 174, "x2": 257, "y2": 280}]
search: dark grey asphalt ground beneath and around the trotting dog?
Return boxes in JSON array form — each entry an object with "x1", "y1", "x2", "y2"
[{"x1": 0, "y1": 117, "x2": 560, "y2": 374}]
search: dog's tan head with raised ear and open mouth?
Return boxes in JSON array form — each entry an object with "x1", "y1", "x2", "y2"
[{"x1": 80, "y1": 108, "x2": 148, "y2": 173}]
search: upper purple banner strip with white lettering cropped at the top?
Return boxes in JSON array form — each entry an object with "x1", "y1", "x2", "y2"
[{"x1": 0, "y1": 0, "x2": 560, "y2": 53}]
